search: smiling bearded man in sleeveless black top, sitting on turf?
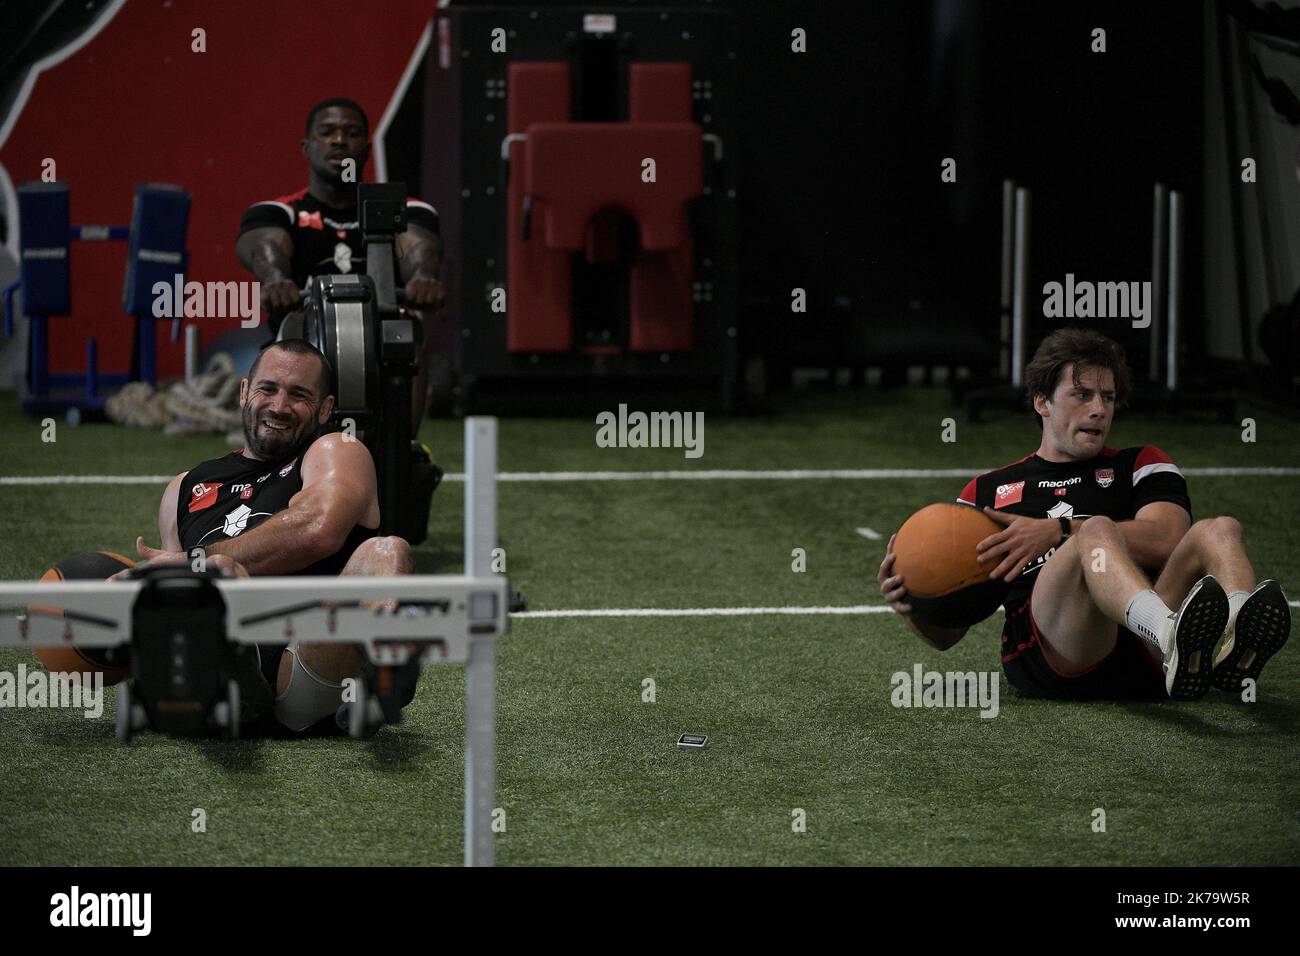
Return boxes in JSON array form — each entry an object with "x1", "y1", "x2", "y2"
[{"x1": 114, "y1": 339, "x2": 412, "y2": 731}]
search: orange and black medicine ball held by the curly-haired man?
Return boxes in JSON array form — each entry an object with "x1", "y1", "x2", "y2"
[{"x1": 893, "y1": 503, "x2": 1010, "y2": 627}]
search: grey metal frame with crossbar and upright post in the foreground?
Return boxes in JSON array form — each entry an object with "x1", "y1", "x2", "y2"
[{"x1": 0, "y1": 418, "x2": 510, "y2": 866}]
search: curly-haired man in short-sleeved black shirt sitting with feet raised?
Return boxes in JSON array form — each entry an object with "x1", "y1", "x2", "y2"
[{"x1": 878, "y1": 329, "x2": 1291, "y2": 700}]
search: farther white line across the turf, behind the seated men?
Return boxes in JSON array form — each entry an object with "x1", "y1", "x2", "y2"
[{"x1": 0, "y1": 468, "x2": 1300, "y2": 485}]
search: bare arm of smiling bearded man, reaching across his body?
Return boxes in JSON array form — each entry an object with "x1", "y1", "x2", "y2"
[{"x1": 200, "y1": 434, "x2": 380, "y2": 575}]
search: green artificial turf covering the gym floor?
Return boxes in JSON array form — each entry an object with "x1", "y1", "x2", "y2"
[{"x1": 0, "y1": 389, "x2": 1300, "y2": 865}]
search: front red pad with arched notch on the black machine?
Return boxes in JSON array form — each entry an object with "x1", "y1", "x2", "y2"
[{"x1": 524, "y1": 122, "x2": 703, "y2": 252}]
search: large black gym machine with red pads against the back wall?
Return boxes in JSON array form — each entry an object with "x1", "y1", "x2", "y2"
[{"x1": 421, "y1": 5, "x2": 742, "y2": 414}]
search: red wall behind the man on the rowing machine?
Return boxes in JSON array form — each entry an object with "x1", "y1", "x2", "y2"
[{"x1": 0, "y1": 0, "x2": 434, "y2": 376}]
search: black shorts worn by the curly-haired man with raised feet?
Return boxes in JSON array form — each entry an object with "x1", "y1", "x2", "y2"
[{"x1": 1002, "y1": 593, "x2": 1167, "y2": 700}]
